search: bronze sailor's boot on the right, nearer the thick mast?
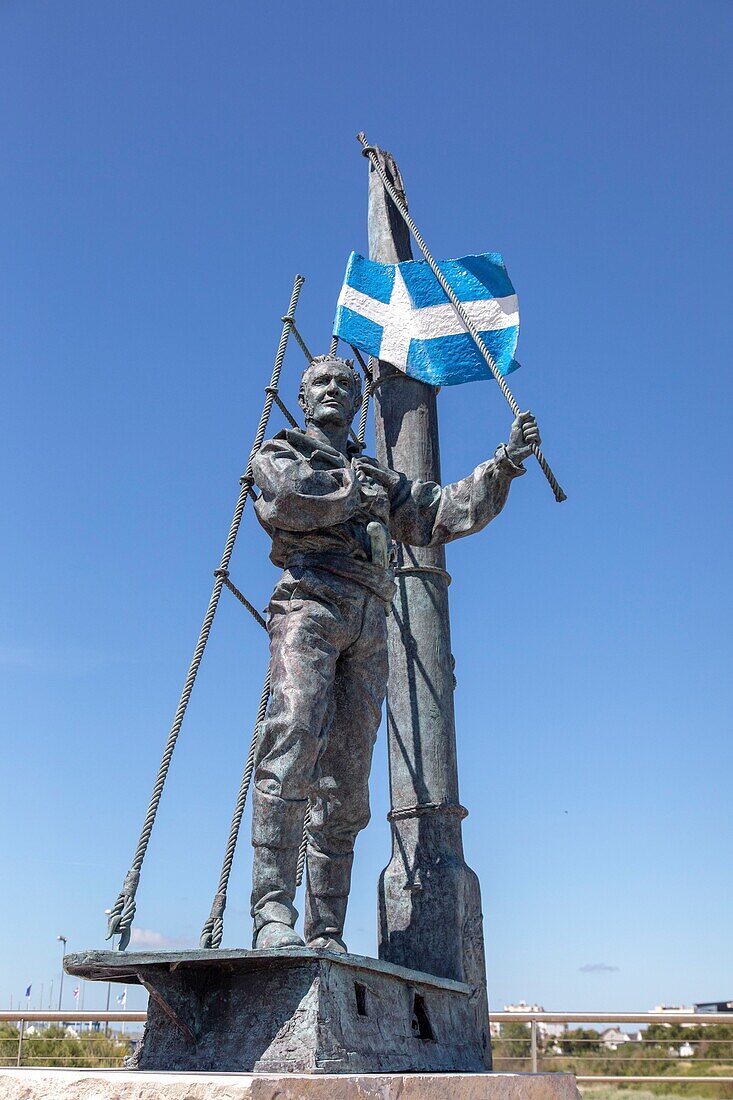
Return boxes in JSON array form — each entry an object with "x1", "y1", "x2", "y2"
[{"x1": 305, "y1": 845, "x2": 353, "y2": 954}]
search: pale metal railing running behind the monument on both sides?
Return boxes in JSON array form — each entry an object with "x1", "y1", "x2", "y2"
[{"x1": 0, "y1": 1010, "x2": 733, "y2": 1085}]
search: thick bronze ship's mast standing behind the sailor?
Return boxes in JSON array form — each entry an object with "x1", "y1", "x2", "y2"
[{"x1": 368, "y1": 137, "x2": 491, "y2": 1069}]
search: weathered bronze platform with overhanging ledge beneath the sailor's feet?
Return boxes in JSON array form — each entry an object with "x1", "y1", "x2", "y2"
[{"x1": 64, "y1": 947, "x2": 484, "y2": 1074}]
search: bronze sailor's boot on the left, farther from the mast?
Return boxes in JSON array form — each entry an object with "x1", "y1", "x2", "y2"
[{"x1": 252, "y1": 785, "x2": 307, "y2": 948}]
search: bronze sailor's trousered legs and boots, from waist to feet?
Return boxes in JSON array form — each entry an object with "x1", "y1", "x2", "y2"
[{"x1": 252, "y1": 568, "x2": 387, "y2": 936}]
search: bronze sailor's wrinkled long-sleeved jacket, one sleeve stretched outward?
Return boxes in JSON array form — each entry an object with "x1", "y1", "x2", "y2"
[{"x1": 252, "y1": 430, "x2": 525, "y2": 603}]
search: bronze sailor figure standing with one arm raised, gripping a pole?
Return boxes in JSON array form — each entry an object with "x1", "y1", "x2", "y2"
[{"x1": 252, "y1": 355, "x2": 540, "y2": 952}]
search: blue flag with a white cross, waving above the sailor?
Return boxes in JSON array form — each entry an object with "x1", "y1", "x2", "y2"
[{"x1": 333, "y1": 252, "x2": 519, "y2": 386}]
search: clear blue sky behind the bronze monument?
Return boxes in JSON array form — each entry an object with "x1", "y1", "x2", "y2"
[{"x1": 0, "y1": 0, "x2": 733, "y2": 1010}]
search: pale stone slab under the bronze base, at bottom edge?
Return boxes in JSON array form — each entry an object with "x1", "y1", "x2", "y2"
[{"x1": 0, "y1": 1069, "x2": 580, "y2": 1100}]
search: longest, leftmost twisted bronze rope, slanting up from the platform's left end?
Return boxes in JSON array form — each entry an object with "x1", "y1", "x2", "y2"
[{"x1": 107, "y1": 275, "x2": 305, "y2": 952}]
